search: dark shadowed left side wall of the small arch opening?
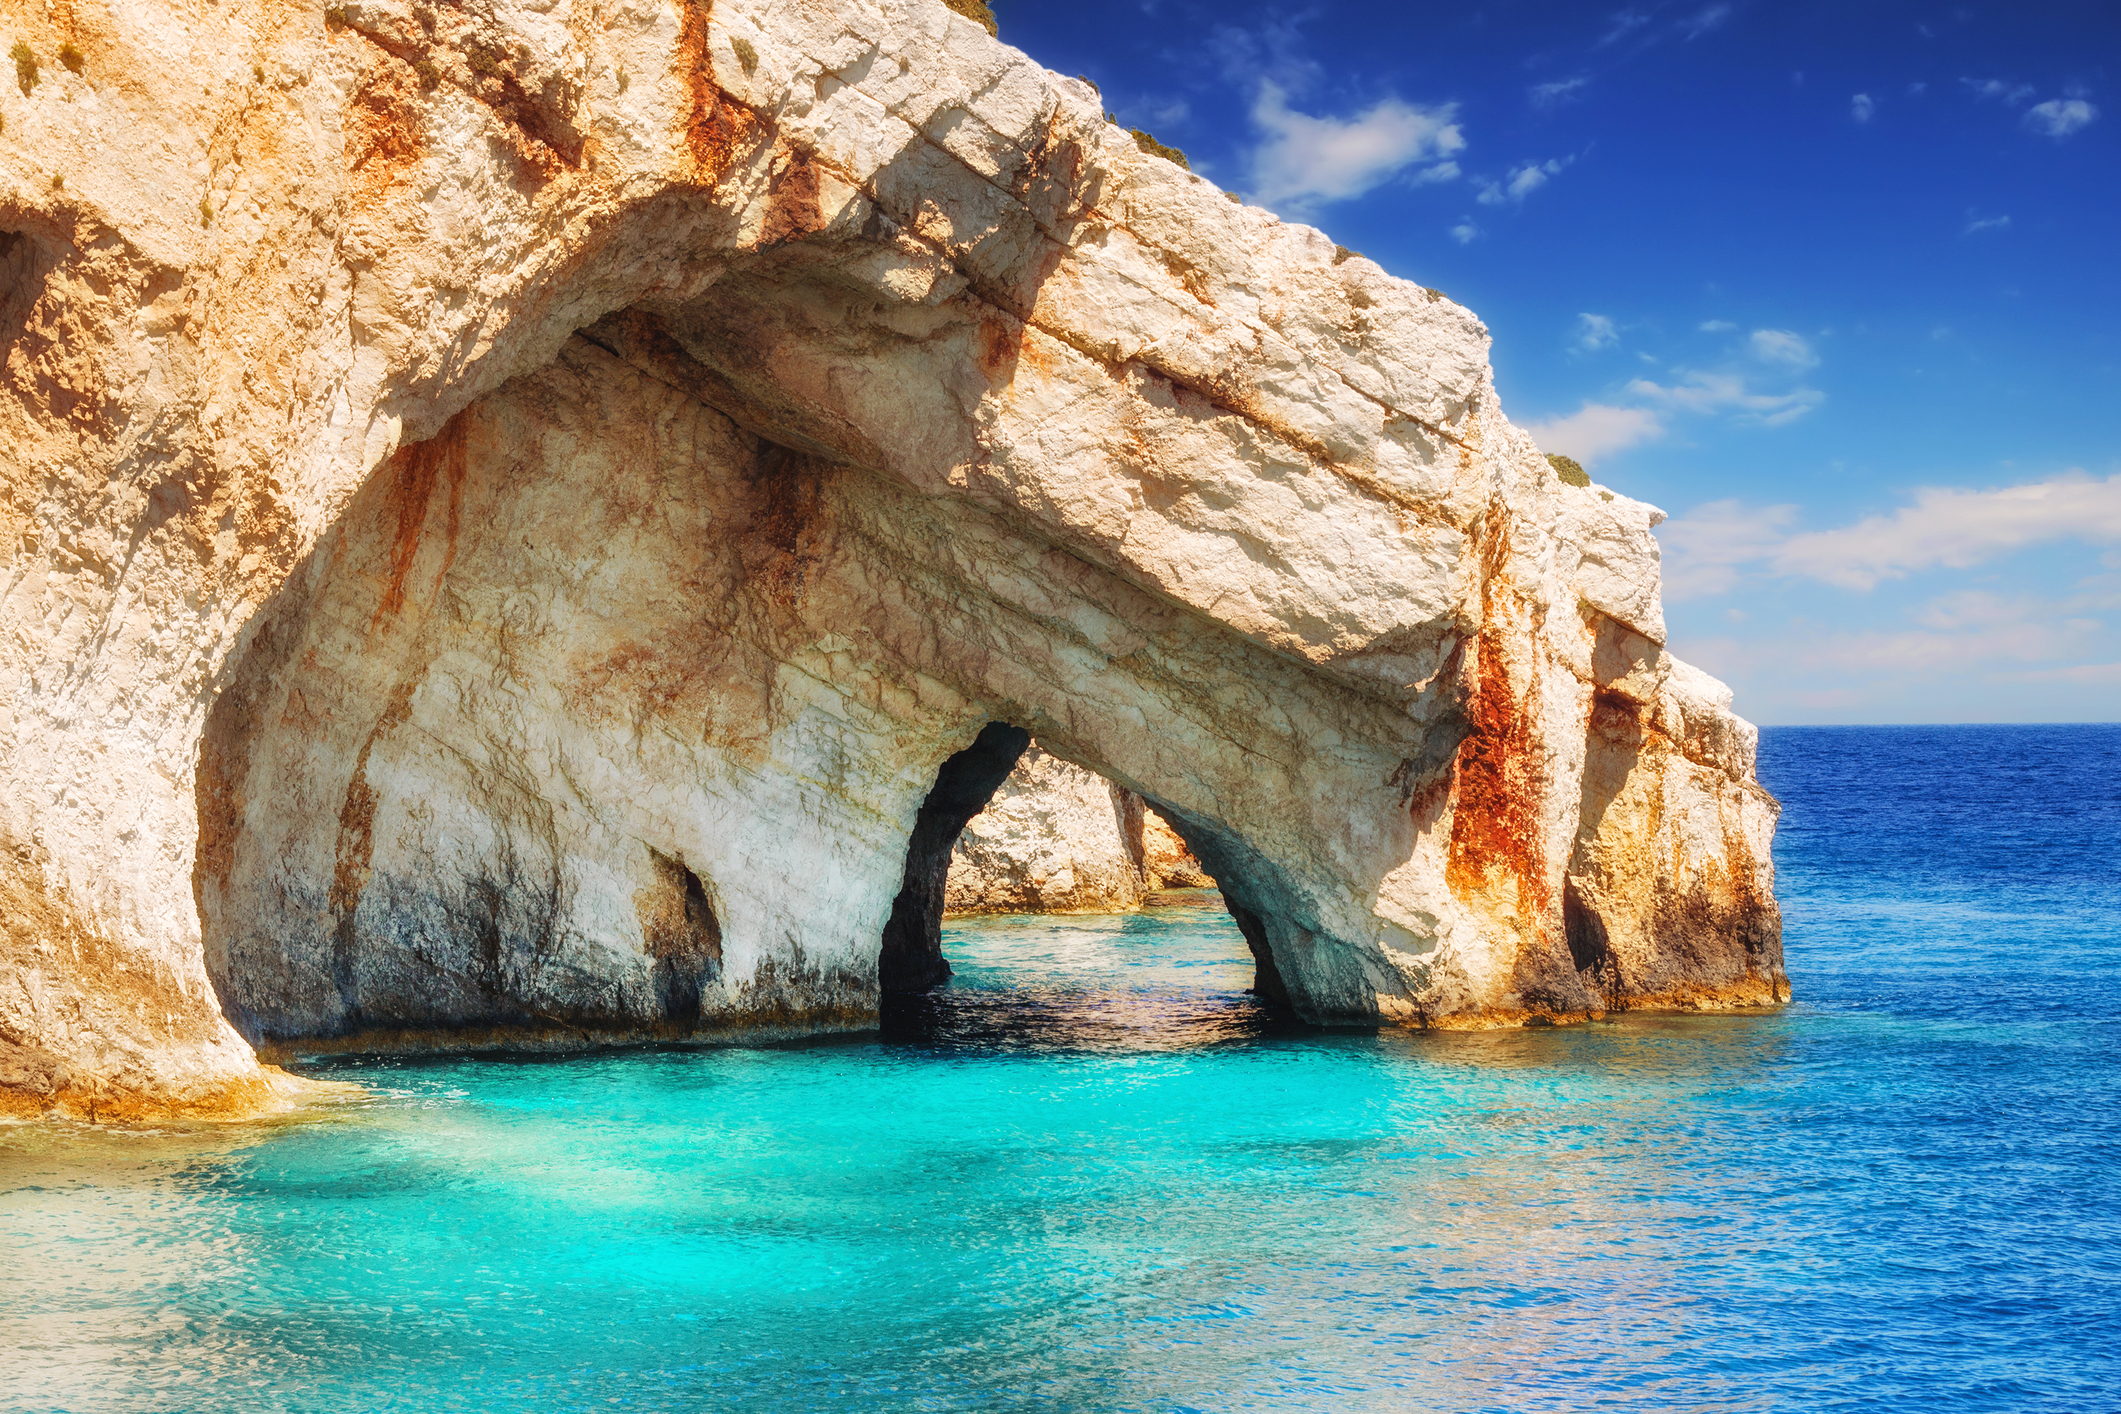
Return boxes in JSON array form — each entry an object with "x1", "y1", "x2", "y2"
[{"x1": 876, "y1": 721, "x2": 1031, "y2": 996}]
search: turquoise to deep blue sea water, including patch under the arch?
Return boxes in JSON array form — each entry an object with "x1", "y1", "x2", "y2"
[{"x1": 0, "y1": 727, "x2": 2121, "y2": 1412}]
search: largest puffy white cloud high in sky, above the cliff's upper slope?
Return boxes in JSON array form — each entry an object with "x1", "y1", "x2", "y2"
[{"x1": 1251, "y1": 81, "x2": 1466, "y2": 208}]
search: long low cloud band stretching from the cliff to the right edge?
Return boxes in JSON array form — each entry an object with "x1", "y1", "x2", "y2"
[{"x1": 1661, "y1": 471, "x2": 2121, "y2": 593}]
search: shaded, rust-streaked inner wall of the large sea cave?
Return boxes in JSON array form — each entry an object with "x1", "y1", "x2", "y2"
[{"x1": 193, "y1": 292, "x2": 1323, "y2": 1056}]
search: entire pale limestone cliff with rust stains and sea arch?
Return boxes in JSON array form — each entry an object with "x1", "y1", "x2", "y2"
[{"x1": 0, "y1": 0, "x2": 1786, "y2": 1113}]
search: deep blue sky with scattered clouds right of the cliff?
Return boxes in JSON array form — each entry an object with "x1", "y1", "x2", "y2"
[{"x1": 995, "y1": 0, "x2": 2121, "y2": 723}]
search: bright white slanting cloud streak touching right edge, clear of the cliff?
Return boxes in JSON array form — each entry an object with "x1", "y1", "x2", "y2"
[{"x1": 1773, "y1": 473, "x2": 2121, "y2": 589}]
